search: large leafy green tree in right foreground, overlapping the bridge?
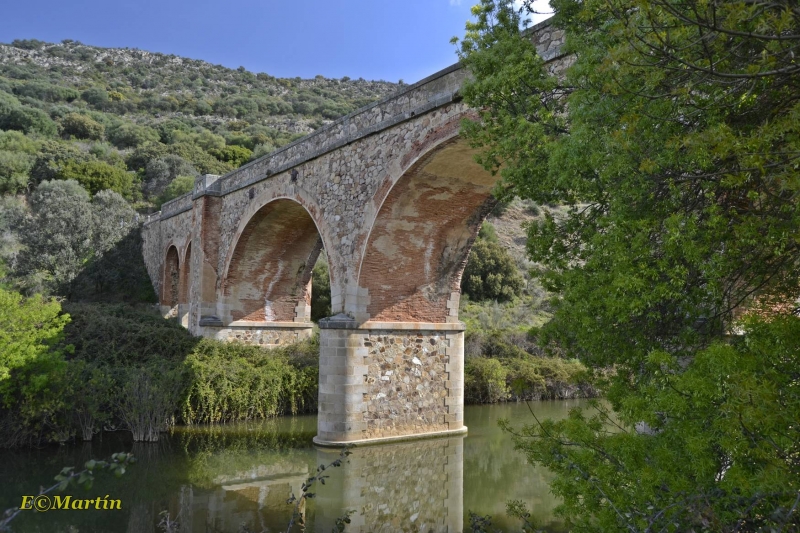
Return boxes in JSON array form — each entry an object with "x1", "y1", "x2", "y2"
[{"x1": 460, "y1": 0, "x2": 800, "y2": 531}]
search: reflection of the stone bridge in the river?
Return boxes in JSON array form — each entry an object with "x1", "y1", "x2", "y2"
[{"x1": 170, "y1": 436, "x2": 464, "y2": 533}]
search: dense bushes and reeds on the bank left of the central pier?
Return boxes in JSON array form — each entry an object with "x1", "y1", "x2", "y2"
[{"x1": 0, "y1": 298, "x2": 319, "y2": 448}]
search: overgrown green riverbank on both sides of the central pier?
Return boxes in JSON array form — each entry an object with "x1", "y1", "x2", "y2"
[{"x1": 0, "y1": 304, "x2": 596, "y2": 448}]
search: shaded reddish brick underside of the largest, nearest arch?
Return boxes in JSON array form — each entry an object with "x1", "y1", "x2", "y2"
[{"x1": 358, "y1": 136, "x2": 499, "y2": 323}]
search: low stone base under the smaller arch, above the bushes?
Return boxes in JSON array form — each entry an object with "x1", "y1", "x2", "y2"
[{"x1": 199, "y1": 320, "x2": 314, "y2": 347}]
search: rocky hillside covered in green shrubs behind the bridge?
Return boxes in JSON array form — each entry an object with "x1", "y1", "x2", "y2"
[{"x1": 0, "y1": 40, "x2": 399, "y2": 203}]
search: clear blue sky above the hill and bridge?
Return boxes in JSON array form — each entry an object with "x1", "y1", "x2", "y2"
[{"x1": 0, "y1": 0, "x2": 549, "y2": 83}]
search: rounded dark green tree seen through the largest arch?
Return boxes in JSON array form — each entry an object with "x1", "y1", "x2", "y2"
[{"x1": 461, "y1": 222, "x2": 525, "y2": 302}]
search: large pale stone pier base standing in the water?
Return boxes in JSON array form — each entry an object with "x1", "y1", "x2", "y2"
[{"x1": 314, "y1": 315, "x2": 466, "y2": 446}]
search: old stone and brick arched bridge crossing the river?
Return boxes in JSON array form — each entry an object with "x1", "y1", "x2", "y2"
[{"x1": 143, "y1": 22, "x2": 564, "y2": 444}]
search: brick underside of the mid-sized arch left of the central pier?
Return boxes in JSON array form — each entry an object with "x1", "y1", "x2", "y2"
[{"x1": 221, "y1": 198, "x2": 323, "y2": 323}]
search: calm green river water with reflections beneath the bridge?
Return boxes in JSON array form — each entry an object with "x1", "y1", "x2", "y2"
[{"x1": 0, "y1": 400, "x2": 585, "y2": 533}]
